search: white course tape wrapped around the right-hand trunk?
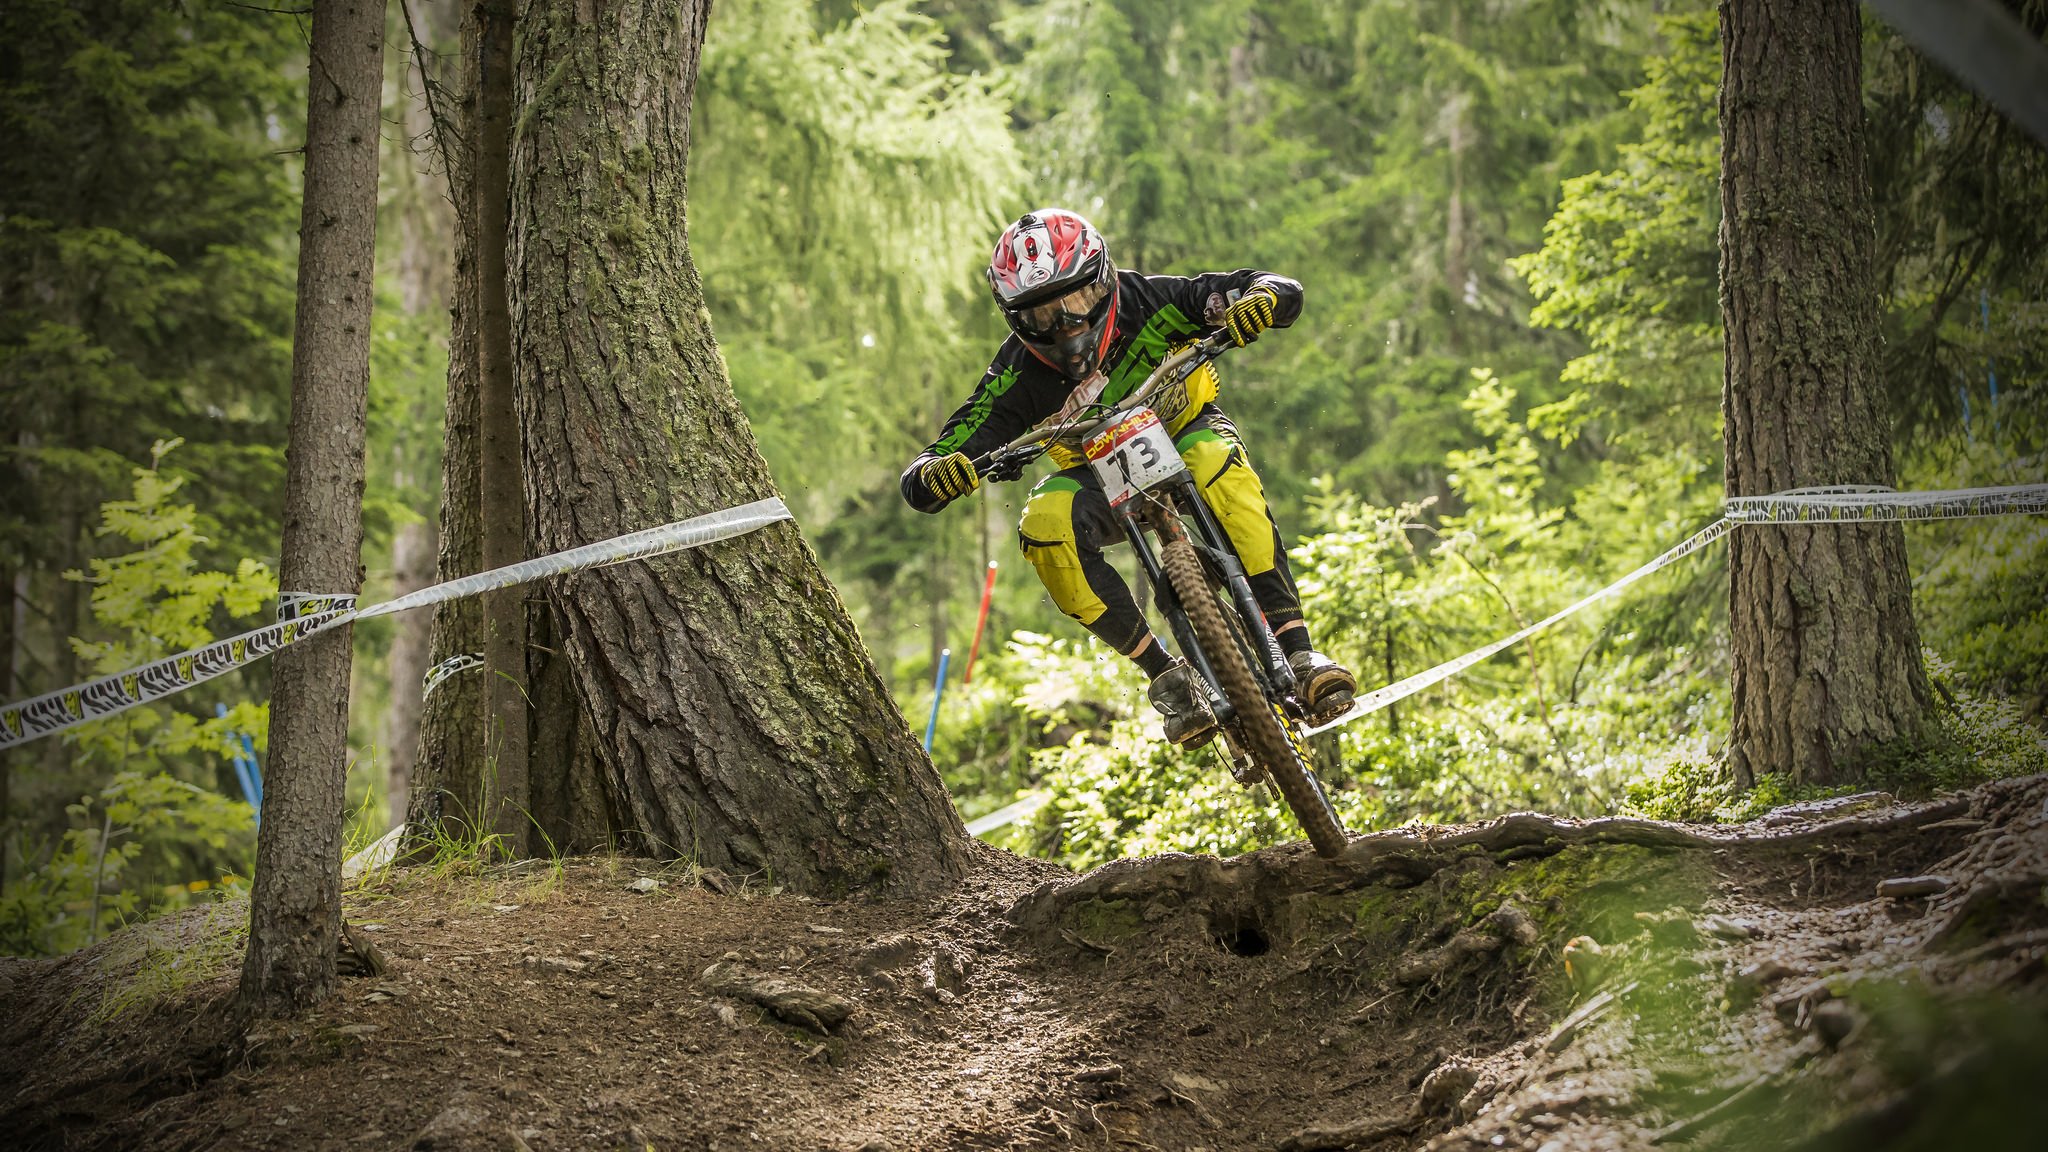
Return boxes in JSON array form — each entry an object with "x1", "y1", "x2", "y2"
[{"x1": 1303, "y1": 484, "x2": 2048, "y2": 736}]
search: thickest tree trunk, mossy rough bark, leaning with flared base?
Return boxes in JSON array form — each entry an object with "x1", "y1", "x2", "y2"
[{"x1": 512, "y1": 0, "x2": 967, "y2": 894}]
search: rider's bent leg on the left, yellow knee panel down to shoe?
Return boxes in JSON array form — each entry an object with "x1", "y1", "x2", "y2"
[{"x1": 1018, "y1": 467, "x2": 1214, "y2": 744}]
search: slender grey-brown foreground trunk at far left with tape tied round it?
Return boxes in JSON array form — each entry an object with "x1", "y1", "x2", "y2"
[{"x1": 242, "y1": 0, "x2": 383, "y2": 1015}]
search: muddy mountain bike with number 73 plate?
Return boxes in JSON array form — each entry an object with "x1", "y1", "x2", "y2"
[{"x1": 973, "y1": 332, "x2": 1346, "y2": 857}]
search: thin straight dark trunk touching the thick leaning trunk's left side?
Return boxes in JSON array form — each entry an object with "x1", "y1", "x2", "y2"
[{"x1": 471, "y1": 0, "x2": 532, "y2": 857}]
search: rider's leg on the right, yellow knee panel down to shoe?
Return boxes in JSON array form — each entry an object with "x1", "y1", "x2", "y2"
[{"x1": 1176, "y1": 406, "x2": 1358, "y2": 711}]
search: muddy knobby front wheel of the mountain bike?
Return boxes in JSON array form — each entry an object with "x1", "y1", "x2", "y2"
[{"x1": 1159, "y1": 533, "x2": 1346, "y2": 857}]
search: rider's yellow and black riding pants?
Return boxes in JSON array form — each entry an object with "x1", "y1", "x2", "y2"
[{"x1": 1018, "y1": 408, "x2": 1300, "y2": 654}]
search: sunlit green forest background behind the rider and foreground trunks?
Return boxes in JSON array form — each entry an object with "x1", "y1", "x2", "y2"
[{"x1": 0, "y1": 0, "x2": 2048, "y2": 953}]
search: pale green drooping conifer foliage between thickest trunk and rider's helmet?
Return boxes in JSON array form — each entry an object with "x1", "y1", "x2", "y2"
[{"x1": 690, "y1": 0, "x2": 1016, "y2": 515}]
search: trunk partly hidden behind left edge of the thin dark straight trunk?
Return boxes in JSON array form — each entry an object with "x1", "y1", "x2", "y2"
[{"x1": 406, "y1": 6, "x2": 485, "y2": 840}]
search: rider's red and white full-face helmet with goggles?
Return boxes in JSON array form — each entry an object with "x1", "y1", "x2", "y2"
[{"x1": 989, "y1": 207, "x2": 1116, "y2": 379}]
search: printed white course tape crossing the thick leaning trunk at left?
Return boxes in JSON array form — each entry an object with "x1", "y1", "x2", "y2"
[{"x1": 0, "y1": 498, "x2": 791, "y2": 748}]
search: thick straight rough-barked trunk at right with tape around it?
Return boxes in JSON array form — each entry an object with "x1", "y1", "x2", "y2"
[{"x1": 1720, "y1": 0, "x2": 1927, "y2": 785}]
